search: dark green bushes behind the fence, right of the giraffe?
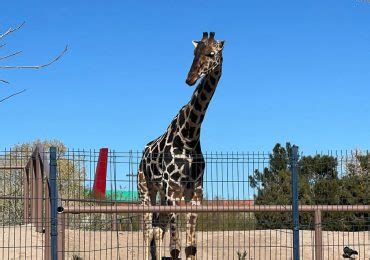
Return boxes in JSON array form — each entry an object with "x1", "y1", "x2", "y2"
[{"x1": 249, "y1": 143, "x2": 370, "y2": 231}]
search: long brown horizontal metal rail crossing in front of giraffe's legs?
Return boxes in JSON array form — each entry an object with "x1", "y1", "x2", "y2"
[{"x1": 58, "y1": 205, "x2": 370, "y2": 214}]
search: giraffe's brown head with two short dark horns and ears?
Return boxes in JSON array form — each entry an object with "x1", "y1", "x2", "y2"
[{"x1": 186, "y1": 32, "x2": 225, "y2": 86}]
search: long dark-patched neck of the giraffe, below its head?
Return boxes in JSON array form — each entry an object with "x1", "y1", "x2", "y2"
[{"x1": 177, "y1": 65, "x2": 222, "y2": 148}]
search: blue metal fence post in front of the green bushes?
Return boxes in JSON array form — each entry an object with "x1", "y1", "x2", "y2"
[{"x1": 290, "y1": 145, "x2": 299, "y2": 260}]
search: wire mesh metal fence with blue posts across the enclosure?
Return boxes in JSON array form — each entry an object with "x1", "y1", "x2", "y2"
[{"x1": 0, "y1": 146, "x2": 370, "y2": 260}]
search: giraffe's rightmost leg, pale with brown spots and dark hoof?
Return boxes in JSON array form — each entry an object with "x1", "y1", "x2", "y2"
[{"x1": 185, "y1": 186, "x2": 203, "y2": 260}]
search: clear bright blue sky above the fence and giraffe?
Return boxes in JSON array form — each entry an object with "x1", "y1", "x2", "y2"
[{"x1": 0, "y1": 0, "x2": 370, "y2": 152}]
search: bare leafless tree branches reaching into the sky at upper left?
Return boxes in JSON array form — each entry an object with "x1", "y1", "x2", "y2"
[{"x1": 0, "y1": 22, "x2": 68, "y2": 103}]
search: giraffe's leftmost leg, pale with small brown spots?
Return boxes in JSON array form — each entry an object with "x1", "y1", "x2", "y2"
[{"x1": 137, "y1": 171, "x2": 153, "y2": 260}]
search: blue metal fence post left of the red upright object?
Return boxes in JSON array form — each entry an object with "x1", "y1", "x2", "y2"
[{"x1": 49, "y1": 147, "x2": 58, "y2": 260}]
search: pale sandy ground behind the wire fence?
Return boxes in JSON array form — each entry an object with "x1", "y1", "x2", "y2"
[{"x1": 0, "y1": 225, "x2": 370, "y2": 260}]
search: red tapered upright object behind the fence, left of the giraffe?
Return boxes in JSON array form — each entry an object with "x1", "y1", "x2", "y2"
[{"x1": 93, "y1": 148, "x2": 108, "y2": 199}]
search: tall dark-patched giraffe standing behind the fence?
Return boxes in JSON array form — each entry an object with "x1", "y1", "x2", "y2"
[{"x1": 137, "y1": 32, "x2": 224, "y2": 260}]
